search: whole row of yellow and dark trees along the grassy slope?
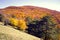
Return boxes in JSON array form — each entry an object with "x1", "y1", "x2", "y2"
[{"x1": 0, "y1": 14, "x2": 59, "y2": 40}]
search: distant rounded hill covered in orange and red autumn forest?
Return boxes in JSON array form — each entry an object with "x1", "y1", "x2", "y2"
[{"x1": 0, "y1": 6, "x2": 60, "y2": 25}]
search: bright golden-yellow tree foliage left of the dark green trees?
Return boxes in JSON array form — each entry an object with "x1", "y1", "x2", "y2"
[{"x1": 9, "y1": 18, "x2": 27, "y2": 30}]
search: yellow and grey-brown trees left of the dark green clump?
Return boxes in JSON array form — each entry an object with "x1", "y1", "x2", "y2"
[{"x1": 0, "y1": 14, "x2": 27, "y2": 31}]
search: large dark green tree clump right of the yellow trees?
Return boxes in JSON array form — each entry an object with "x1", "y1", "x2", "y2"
[{"x1": 27, "y1": 16, "x2": 57, "y2": 40}]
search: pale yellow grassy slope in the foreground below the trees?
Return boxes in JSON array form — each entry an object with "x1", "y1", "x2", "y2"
[{"x1": 0, "y1": 23, "x2": 41, "y2": 40}]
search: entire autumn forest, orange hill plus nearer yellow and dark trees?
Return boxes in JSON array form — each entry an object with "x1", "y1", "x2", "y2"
[{"x1": 0, "y1": 6, "x2": 60, "y2": 40}]
